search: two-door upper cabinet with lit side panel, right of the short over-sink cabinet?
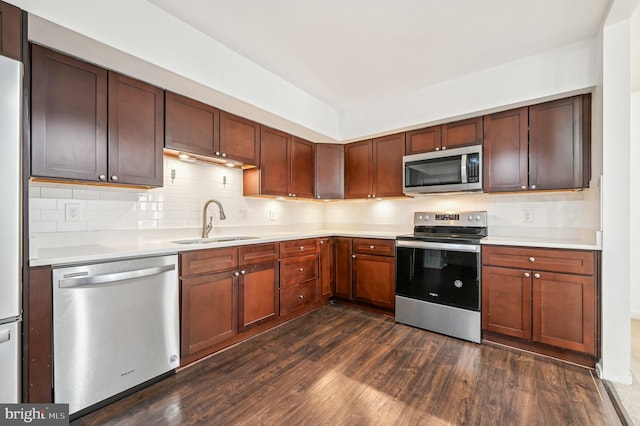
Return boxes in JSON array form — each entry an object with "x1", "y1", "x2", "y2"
[{"x1": 243, "y1": 126, "x2": 315, "y2": 198}]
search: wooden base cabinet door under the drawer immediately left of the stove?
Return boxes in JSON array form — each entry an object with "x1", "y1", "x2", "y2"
[{"x1": 353, "y1": 254, "x2": 396, "y2": 309}]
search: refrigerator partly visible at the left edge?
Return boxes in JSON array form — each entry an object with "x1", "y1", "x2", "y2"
[{"x1": 0, "y1": 56, "x2": 23, "y2": 403}]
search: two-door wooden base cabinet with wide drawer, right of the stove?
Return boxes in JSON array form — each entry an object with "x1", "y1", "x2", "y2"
[{"x1": 482, "y1": 246, "x2": 599, "y2": 357}]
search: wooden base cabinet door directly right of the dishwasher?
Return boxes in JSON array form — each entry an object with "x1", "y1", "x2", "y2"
[{"x1": 181, "y1": 271, "x2": 238, "y2": 358}]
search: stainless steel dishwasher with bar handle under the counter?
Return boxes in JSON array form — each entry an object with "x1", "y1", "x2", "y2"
[{"x1": 53, "y1": 255, "x2": 180, "y2": 414}]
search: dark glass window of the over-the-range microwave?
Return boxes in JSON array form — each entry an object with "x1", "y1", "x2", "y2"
[{"x1": 404, "y1": 155, "x2": 462, "y2": 188}]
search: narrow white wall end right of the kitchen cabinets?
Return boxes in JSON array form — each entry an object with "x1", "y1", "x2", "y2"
[{"x1": 598, "y1": 15, "x2": 631, "y2": 383}]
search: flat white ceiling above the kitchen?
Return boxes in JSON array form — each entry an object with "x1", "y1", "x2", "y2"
[{"x1": 147, "y1": 0, "x2": 610, "y2": 111}]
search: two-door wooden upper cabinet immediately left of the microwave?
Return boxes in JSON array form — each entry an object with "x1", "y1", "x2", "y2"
[{"x1": 345, "y1": 133, "x2": 405, "y2": 198}]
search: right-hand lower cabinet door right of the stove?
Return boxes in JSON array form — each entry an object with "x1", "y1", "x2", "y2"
[{"x1": 528, "y1": 271, "x2": 596, "y2": 355}]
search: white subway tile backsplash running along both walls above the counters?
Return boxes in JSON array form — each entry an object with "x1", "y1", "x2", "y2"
[{"x1": 29, "y1": 157, "x2": 600, "y2": 243}]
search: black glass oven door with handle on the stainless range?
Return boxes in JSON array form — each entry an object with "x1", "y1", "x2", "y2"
[{"x1": 396, "y1": 240, "x2": 480, "y2": 311}]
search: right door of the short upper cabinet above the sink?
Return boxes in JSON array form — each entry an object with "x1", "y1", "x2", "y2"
[{"x1": 220, "y1": 111, "x2": 260, "y2": 166}]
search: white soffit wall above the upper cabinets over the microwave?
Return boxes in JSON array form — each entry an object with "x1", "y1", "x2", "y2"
[{"x1": 340, "y1": 38, "x2": 598, "y2": 140}]
